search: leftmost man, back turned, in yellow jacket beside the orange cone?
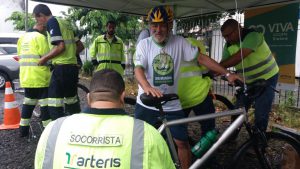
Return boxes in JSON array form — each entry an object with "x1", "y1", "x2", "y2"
[{"x1": 17, "y1": 24, "x2": 51, "y2": 137}]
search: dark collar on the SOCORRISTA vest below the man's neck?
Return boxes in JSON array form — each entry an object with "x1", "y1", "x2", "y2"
[{"x1": 83, "y1": 107, "x2": 128, "y2": 115}]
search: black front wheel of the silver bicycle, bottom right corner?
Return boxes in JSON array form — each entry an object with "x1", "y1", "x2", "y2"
[{"x1": 228, "y1": 132, "x2": 300, "y2": 169}]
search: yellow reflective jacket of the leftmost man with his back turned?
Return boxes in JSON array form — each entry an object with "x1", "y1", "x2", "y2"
[{"x1": 17, "y1": 32, "x2": 51, "y2": 88}]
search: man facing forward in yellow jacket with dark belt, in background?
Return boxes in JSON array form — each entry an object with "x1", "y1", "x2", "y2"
[{"x1": 90, "y1": 21, "x2": 125, "y2": 76}]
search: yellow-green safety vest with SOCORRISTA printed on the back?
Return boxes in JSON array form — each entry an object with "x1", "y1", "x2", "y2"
[{"x1": 35, "y1": 113, "x2": 175, "y2": 169}]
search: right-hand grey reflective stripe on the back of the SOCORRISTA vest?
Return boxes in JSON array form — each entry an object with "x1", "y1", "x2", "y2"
[{"x1": 130, "y1": 119, "x2": 144, "y2": 169}]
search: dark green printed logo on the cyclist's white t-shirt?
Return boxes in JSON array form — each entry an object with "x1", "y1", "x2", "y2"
[{"x1": 152, "y1": 53, "x2": 174, "y2": 86}]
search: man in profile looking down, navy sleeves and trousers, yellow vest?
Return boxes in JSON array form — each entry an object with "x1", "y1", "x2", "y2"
[{"x1": 33, "y1": 4, "x2": 81, "y2": 120}]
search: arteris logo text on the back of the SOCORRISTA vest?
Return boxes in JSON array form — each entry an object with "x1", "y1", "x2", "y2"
[{"x1": 64, "y1": 152, "x2": 121, "y2": 169}]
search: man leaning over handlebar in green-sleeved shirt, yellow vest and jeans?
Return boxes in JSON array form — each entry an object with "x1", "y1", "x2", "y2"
[{"x1": 220, "y1": 19, "x2": 279, "y2": 131}]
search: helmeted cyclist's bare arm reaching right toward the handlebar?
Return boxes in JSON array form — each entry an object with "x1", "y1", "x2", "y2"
[{"x1": 197, "y1": 53, "x2": 242, "y2": 83}]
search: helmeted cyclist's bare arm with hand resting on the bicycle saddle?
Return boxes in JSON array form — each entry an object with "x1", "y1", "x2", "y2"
[{"x1": 134, "y1": 66, "x2": 162, "y2": 97}]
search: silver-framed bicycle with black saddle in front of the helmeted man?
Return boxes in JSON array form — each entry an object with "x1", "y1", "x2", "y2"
[{"x1": 141, "y1": 88, "x2": 300, "y2": 169}]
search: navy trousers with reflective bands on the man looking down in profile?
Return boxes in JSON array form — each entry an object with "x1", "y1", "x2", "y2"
[{"x1": 48, "y1": 65, "x2": 80, "y2": 120}]
